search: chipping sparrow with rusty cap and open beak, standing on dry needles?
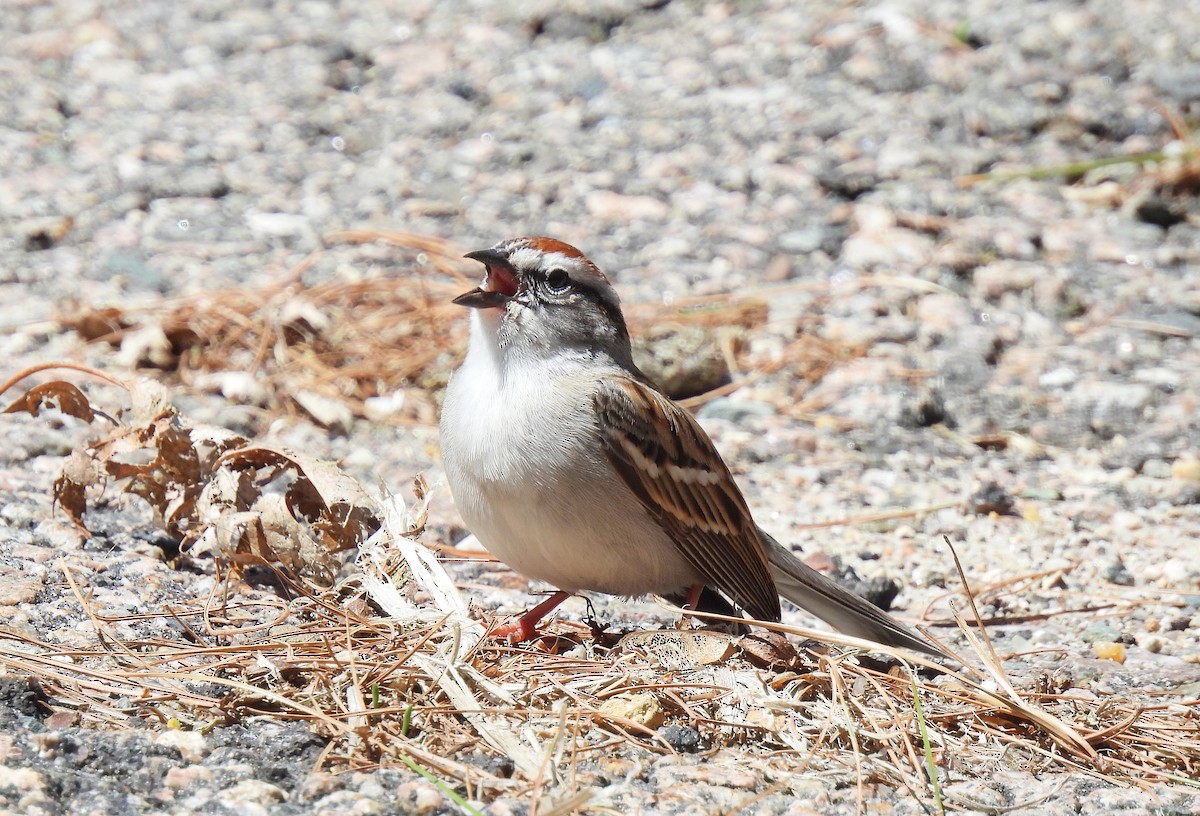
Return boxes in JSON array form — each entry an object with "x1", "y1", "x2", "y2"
[{"x1": 440, "y1": 238, "x2": 938, "y2": 654}]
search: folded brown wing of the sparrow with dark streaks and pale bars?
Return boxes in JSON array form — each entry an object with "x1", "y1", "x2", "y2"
[{"x1": 593, "y1": 379, "x2": 779, "y2": 620}]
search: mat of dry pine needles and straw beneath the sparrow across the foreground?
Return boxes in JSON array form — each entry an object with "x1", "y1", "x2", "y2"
[{"x1": 0, "y1": 516, "x2": 1200, "y2": 811}]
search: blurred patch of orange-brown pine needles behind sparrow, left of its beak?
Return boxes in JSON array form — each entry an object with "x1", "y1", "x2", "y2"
[{"x1": 59, "y1": 230, "x2": 464, "y2": 425}]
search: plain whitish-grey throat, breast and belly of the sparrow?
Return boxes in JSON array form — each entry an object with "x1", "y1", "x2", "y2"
[{"x1": 442, "y1": 312, "x2": 702, "y2": 595}]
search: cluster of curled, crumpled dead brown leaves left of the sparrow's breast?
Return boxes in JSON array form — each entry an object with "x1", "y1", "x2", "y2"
[{"x1": 5, "y1": 369, "x2": 379, "y2": 586}]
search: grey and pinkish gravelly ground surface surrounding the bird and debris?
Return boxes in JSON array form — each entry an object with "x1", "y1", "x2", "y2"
[{"x1": 0, "y1": 0, "x2": 1200, "y2": 816}]
